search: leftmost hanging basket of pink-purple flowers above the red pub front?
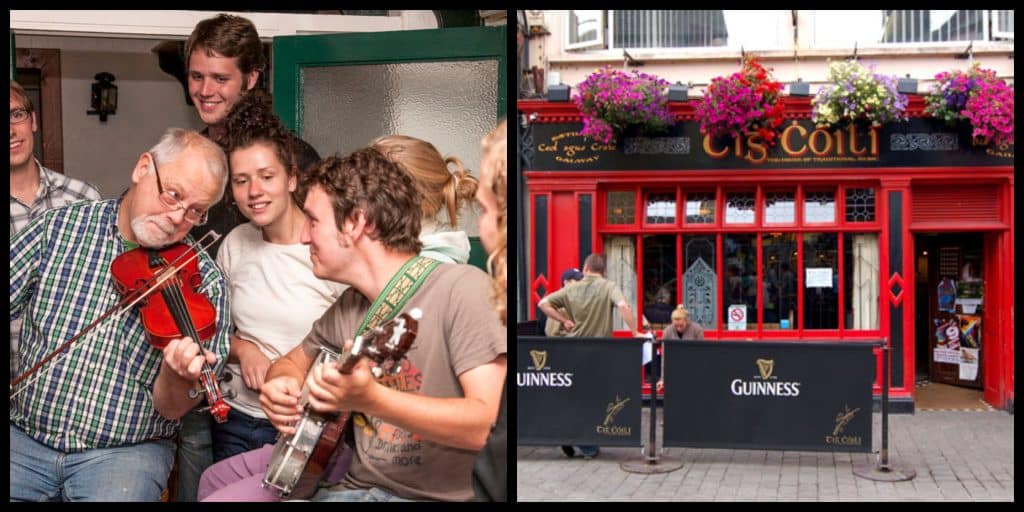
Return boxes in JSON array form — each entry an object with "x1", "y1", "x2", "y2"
[{"x1": 572, "y1": 68, "x2": 675, "y2": 144}]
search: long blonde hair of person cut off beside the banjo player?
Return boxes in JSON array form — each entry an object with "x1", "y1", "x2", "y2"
[{"x1": 480, "y1": 120, "x2": 508, "y2": 325}]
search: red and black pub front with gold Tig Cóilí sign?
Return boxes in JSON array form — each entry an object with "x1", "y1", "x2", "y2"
[{"x1": 518, "y1": 95, "x2": 1014, "y2": 413}]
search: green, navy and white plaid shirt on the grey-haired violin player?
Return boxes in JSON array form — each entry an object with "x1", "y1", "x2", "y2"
[{"x1": 10, "y1": 200, "x2": 230, "y2": 453}]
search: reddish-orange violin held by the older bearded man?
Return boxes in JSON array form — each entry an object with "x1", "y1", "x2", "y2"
[{"x1": 111, "y1": 239, "x2": 231, "y2": 423}]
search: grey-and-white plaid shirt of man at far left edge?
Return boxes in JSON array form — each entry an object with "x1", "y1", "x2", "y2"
[{"x1": 10, "y1": 159, "x2": 99, "y2": 375}]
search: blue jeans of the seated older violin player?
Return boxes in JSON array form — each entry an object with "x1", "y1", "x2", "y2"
[{"x1": 10, "y1": 425, "x2": 174, "y2": 502}]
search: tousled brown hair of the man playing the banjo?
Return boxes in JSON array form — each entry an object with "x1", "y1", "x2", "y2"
[{"x1": 301, "y1": 147, "x2": 423, "y2": 254}]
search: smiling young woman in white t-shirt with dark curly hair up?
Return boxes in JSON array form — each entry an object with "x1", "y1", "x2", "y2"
[{"x1": 213, "y1": 92, "x2": 346, "y2": 462}]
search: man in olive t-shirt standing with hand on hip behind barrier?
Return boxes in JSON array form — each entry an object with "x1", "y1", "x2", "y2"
[{"x1": 538, "y1": 254, "x2": 637, "y2": 459}]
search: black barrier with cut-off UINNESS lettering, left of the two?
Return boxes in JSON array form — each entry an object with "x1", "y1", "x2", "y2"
[{"x1": 516, "y1": 336, "x2": 642, "y2": 446}]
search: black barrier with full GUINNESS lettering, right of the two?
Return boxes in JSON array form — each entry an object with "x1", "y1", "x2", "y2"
[{"x1": 663, "y1": 340, "x2": 874, "y2": 452}]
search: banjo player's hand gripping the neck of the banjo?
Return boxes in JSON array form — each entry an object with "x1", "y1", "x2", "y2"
[{"x1": 306, "y1": 340, "x2": 376, "y2": 413}]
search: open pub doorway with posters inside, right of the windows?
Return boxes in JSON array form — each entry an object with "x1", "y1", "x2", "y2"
[{"x1": 914, "y1": 232, "x2": 988, "y2": 410}]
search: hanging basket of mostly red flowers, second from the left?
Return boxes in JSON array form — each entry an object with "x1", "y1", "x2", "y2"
[{"x1": 696, "y1": 57, "x2": 783, "y2": 145}]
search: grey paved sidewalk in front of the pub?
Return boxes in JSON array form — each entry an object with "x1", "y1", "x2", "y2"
[{"x1": 516, "y1": 409, "x2": 1014, "y2": 502}]
